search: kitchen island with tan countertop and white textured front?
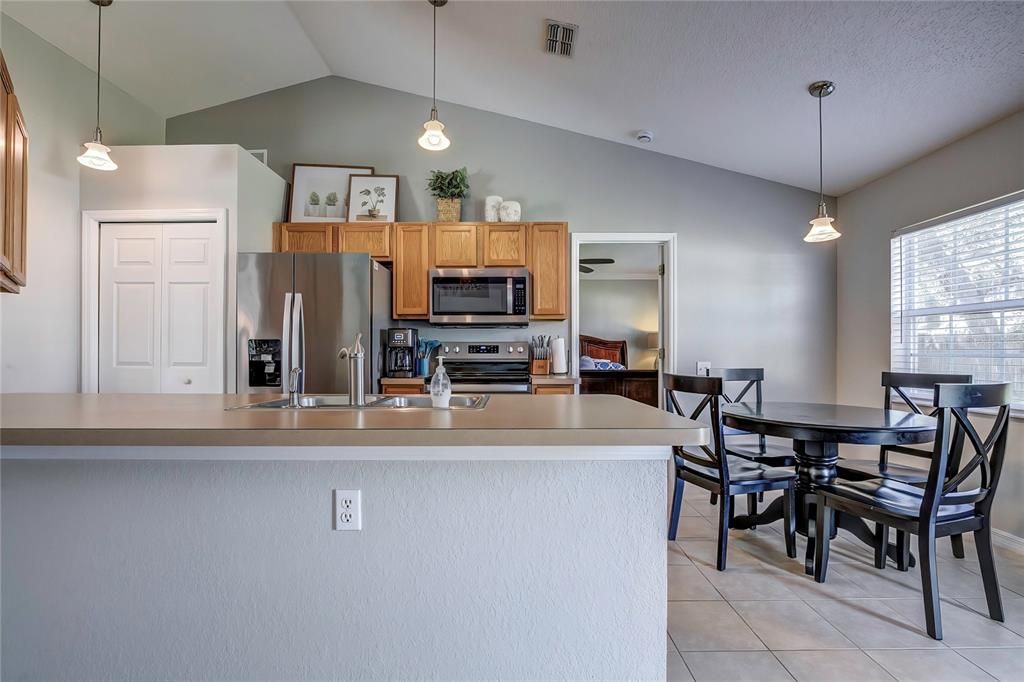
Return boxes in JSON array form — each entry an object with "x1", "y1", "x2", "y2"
[{"x1": 0, "y1": 394, "x2": 710, "y2": 679}]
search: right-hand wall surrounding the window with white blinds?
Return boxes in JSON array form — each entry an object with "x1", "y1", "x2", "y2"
[{"x1": 836, "y1": 112, "x2": 1024, "y2": 537}]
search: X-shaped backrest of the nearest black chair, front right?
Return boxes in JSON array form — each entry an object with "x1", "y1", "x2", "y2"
[{"x1": 921, "y1": 383, "x2": 1013, "y2": 522}]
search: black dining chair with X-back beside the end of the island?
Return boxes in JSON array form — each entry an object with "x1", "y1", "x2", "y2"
[{"x1": 664, "y1": 374, "x2": 797, "y2": 570}]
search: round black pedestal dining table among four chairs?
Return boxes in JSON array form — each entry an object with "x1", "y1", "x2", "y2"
[{"x1": 722, "y1": 402, "x2": 937, "y2": 573}]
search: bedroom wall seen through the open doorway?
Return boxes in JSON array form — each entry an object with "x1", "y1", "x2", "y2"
[{"x1": 580, "y1": 278, "x2": 659, "y2": 372}]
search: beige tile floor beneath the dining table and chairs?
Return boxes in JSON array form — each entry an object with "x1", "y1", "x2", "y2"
[{"x1": 668, "y1": 486, "x2": 1024, "y2": 682}]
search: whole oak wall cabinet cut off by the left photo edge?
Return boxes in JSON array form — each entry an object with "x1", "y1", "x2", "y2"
[{"x1": 0, "y1": 52, "x2": 29, "y2": 294}]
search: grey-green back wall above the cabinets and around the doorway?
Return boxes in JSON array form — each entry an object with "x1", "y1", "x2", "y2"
[{"x1": 167, "y1": 77, "x2": 835, "y2": 400}]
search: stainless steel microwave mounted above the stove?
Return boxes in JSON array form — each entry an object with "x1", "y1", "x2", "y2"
[{"x1": 430, "y1": 267, "x2": 529, "y2": 327}]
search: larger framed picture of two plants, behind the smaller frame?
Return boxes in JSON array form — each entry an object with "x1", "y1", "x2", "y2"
[{"x1": 288, "y1": 164, "x2": 374, "y2": 222}]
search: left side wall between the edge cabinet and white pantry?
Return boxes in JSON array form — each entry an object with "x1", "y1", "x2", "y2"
[{"x1": 0, "y1": 16, "x2": 164, "y2": 392}]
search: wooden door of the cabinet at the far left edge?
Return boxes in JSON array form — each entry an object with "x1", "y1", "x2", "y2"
[{"x1": 3, "y1": 94, "x2": 29, "y2": 287}]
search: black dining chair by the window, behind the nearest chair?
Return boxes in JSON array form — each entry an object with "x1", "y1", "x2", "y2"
[{"x1": 836, "y1": 372, "x2": 973, "y2": 557}]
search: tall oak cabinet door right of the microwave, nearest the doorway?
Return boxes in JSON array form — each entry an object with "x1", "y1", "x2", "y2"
[{"x1": 528, "y1": 222, "x2": 569, "y2": 319}]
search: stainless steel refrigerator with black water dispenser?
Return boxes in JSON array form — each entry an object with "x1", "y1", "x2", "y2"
[{"x1": 236, "y1": 253, "x2": 391, "y2": 393}]
